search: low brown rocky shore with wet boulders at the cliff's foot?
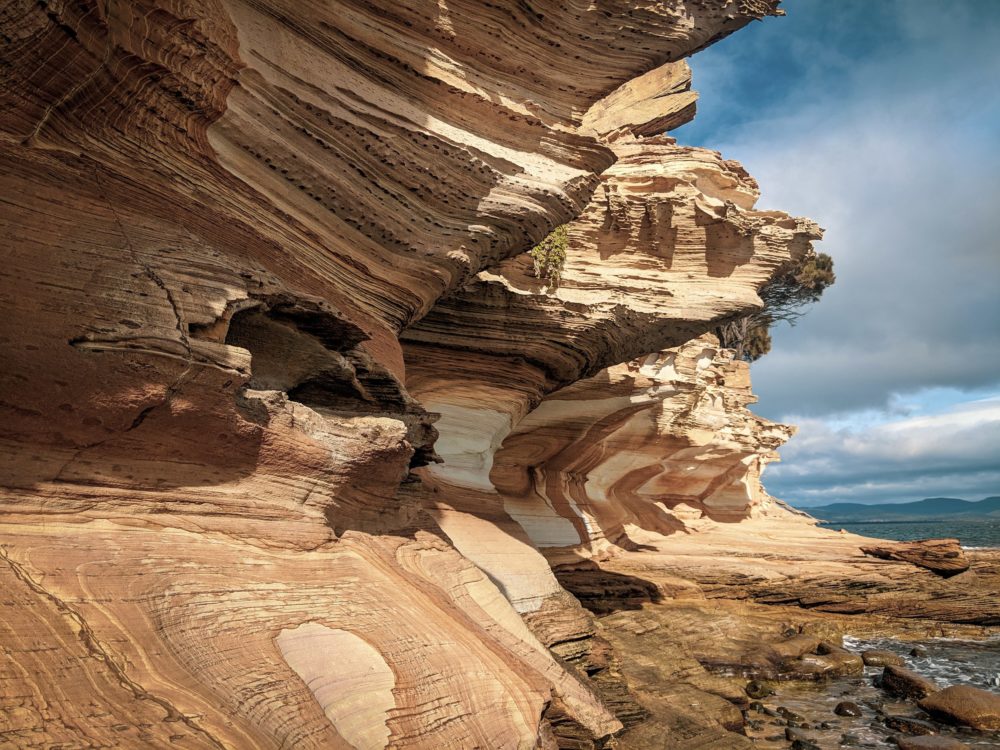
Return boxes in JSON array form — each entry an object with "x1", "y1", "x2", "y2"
[{"x1": 572, "y1": 533, "x2": 1000, "y2": 750}]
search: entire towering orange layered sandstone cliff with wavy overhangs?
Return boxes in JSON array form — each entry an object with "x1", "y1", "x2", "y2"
[{"x1": 0, "y1": 0, "x2": 868, "y2": 748}]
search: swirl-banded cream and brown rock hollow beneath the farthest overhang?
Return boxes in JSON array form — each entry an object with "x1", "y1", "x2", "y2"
[{"x1": 492, "y1": 336, "x2": 792, "y2": 552}]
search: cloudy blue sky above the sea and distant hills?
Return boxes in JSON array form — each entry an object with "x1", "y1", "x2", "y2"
[{"x1": 671, "y1": 0, "x2": 1000, "y2": 507}]
